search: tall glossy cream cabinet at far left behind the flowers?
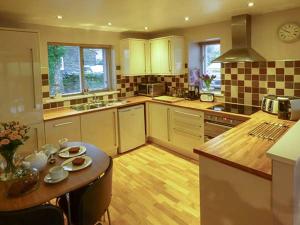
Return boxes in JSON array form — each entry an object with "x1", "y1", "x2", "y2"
[{"x1": 0, "y1": 28, "x2": 45, "y2": 153}]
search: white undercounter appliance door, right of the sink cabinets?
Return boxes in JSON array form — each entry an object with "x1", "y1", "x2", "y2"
[{"x1": 118, "y1": 105, "x2": 146, "y2": 153}]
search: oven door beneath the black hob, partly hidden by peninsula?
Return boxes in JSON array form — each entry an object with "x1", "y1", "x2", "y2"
[{"x1": 204, "y1": 121, "x2": 233, "y2": 141}]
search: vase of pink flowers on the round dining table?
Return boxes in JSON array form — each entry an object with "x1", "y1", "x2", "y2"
[{"x1": 0, "y1": 121, "x2": 29, "y2": 180}]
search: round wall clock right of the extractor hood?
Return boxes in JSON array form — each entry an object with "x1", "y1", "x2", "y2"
[{"x1": 278, "y1": 23, "x2": 300, "y2": 42}]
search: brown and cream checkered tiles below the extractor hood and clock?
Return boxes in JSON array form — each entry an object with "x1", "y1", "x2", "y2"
[{"x1": 222, "y1": 61, "x2": 300, "y2": 106}]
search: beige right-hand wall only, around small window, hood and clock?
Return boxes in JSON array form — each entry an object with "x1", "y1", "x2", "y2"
[{"x1": 151, "y1": 8, "x2": 300, "y2": 61}]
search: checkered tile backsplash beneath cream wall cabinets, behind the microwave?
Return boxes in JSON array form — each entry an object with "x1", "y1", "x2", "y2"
[{"x1": 117, "y1": 74, "x2": 188, "y2": 97}]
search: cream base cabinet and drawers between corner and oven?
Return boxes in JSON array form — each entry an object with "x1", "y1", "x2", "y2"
[{"x1": 147, "y1": 102, "x2": 204, "y2": 158}]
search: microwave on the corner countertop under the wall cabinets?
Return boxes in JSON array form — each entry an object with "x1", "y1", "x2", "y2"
[{"x1": 138, "y1": 82, "x2": 166, "y2": 97}]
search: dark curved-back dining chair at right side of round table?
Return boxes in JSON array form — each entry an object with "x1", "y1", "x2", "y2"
[{"x1": 58, "y1": 157, "x2": 113, "y2": 225}]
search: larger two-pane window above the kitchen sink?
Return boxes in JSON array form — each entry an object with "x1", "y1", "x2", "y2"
[{"x1": 48, "y1": 43, "x2": 110, "y2": 96}]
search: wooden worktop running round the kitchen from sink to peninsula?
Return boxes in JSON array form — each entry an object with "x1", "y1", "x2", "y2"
[{"x1": 44, "y1": 96, "x2": 295, "y2": 180}]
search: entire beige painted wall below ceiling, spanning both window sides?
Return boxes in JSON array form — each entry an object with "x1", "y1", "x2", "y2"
[{"x1": 0, "y1": 8, "x2": 300, "y2": 70}]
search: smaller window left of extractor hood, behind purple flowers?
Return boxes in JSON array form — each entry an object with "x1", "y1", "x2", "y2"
[{"x1": 200, "y1": 42, "x2": 221, "y2": 91}]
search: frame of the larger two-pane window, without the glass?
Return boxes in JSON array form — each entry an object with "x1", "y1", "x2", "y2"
[{"x1": 47, "y1": 42, "x2": 112, "y2": 97}]
